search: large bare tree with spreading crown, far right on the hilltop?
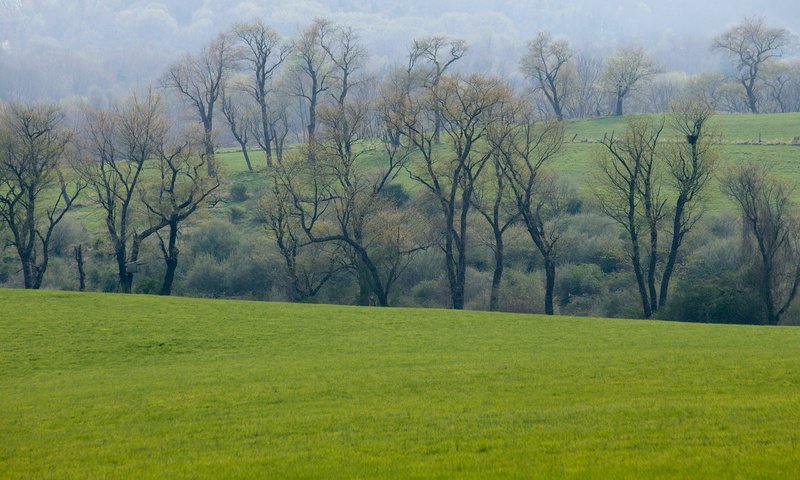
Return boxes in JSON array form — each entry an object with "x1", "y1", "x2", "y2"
[{"x1": 711, "y1": 17, "x2": 790, "y2": 113}]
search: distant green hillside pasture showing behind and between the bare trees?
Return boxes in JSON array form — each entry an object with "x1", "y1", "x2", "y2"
[{"x1": 47, "y1": 113, "x2": 800, "y2": 233}]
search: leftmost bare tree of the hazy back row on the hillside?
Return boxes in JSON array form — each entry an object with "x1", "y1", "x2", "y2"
[{"x1": 161, "y1": 34, "x2": 236, "y2": 175}]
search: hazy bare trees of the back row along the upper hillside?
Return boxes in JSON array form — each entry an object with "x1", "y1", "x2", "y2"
[{"x1": 155, "y1": 18, "x2": 800, "y2": 180}]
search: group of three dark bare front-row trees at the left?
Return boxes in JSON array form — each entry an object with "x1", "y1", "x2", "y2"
[{"x1": 0, "y1": 92, "x2": 219, "y2": 295}]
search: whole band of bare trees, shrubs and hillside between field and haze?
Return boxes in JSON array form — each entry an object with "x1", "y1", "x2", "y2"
[{"x1": 0, "y1": 17, "x2": 800, "y2": 325}]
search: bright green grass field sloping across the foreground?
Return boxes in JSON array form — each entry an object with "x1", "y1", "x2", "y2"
[{"x1": 0, "y1": 290, "x2": 800, "y2": 479}]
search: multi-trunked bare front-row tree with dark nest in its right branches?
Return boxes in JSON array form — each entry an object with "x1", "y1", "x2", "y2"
[{"x1": 598, "y1": 105, "x2": 716, "y2": 318}]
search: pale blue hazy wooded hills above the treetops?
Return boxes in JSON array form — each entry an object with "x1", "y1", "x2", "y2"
[{"x1": 0, "y1": 0, "x2": 800, "y2": 100}]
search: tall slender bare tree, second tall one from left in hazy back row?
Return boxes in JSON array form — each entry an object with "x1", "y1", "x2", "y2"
[{"x1": 233, "y1": 20, "x2": 290, "y2": 167}]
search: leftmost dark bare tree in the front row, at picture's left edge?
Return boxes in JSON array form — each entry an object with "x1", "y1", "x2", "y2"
[{"x1": 0, "y1": 103, "x2": 84, "y2": 289}]
